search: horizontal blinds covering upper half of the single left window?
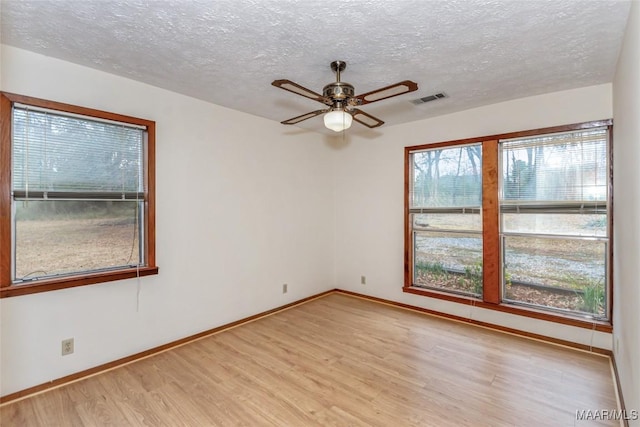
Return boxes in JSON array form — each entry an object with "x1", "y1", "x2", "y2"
[{"x1": 12, "y1": 106, "x2": 145, "y2": 199}]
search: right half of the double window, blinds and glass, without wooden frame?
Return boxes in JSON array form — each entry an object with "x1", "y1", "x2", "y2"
[{"x1": 500, "y1": 128, "x2": 609, "y2": 319}]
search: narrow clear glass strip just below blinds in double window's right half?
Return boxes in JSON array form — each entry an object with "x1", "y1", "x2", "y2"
[{"x1": 502, "y1": 213, "x2": 607, "y2": 237}]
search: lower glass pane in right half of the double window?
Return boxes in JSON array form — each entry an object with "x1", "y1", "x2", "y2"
[{"x1": 503, "y1": 236, "x2": 607, "y2": 318}]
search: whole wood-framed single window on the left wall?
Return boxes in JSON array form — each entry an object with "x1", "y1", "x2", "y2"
[{"x1": 0, "y1": 93, "x2": 157, "y2": 296}]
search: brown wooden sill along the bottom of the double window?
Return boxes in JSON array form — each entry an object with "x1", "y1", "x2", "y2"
[{"x1": 402, "y1": 286, "x2": 613, "y2": 333}]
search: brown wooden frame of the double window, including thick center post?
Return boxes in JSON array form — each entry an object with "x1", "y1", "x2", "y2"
[{"x1": 402, "y1": 119, "x2": 613, "y2": 333}]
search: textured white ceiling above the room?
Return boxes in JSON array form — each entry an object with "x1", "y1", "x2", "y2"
[{"x1": 0, "y1": 0, "x2": 630, "y2": 136}]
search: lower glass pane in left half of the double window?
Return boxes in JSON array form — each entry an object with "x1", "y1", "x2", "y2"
[{"x1": 414, "y1": 231, "x2": 482, "y2": 295}]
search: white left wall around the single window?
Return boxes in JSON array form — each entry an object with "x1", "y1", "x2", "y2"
[{"x1": 0, "y1": 46, "x2": 334, "y2": 395}]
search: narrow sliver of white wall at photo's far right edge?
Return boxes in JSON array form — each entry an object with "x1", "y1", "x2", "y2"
[{"x1": 613, "y1": 1, "x2": 640, "y2": 426}]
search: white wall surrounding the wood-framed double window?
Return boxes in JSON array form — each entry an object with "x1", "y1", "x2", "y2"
[{"x1": 335, "y1": 84, "x2": 612, "y2": 349}]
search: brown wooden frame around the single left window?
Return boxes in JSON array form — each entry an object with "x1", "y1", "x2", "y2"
[{"x1": 0, "y1": 92, "x2": 158, "y2": 298}]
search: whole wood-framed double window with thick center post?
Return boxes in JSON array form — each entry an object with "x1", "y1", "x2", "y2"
[{"x1": 404, "y1": 120, "x2": 612, "y2": 331}]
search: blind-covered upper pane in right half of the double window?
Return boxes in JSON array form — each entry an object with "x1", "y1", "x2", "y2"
[{"x1": 501, "y1": 129, "x2": 608, "y2": 203}]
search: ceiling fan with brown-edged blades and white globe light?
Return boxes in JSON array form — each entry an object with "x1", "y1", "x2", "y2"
[{"x1": 271, "y1": 61, "x2": 418, "y2": 132}]
